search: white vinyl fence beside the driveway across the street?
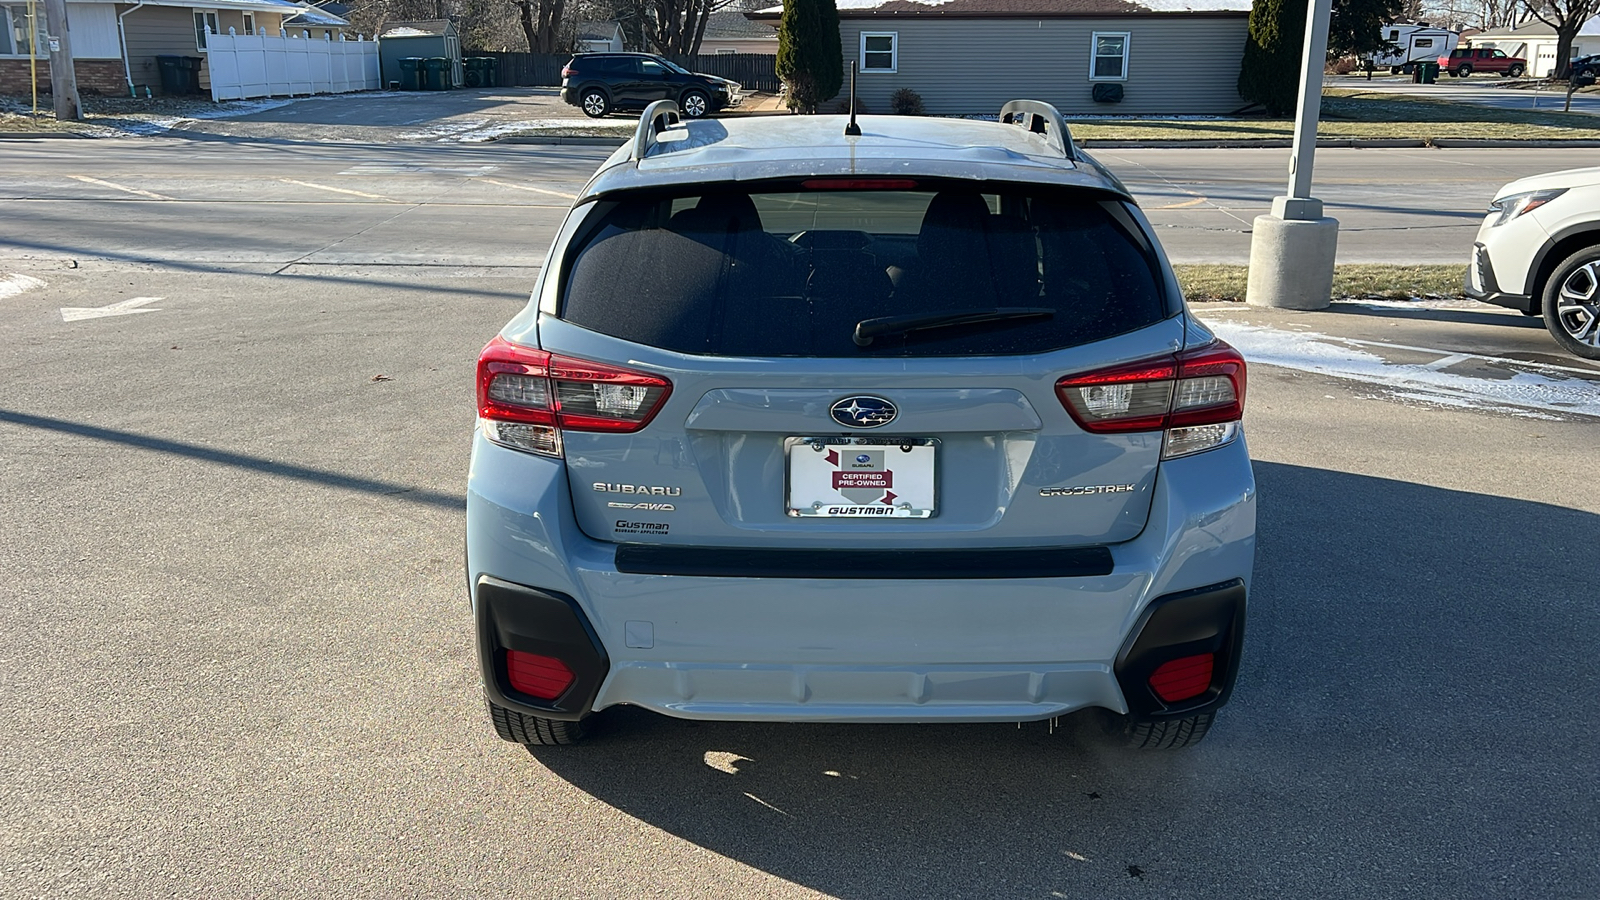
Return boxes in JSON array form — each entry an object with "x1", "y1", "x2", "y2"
[{"x1": 205, "y1": 29, "x2": 381, "y2": 99}]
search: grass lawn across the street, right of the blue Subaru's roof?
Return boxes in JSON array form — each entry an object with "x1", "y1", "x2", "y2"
[{"x1": 1070, "y1": 88, "x2": 1600, "y2": 141}]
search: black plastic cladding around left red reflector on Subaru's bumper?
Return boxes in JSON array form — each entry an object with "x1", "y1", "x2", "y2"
[{"x1": 477, "y1": 575, "x2": 611, "y2": 721}]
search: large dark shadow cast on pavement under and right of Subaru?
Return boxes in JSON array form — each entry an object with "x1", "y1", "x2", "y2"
[{"x1": 524, "y1": 461, "x2": 1600, "y2": 898}]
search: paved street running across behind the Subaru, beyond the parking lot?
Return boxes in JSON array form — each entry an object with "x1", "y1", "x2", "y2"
[{"x1": 0, "y1": 138, "x2": 1594, "y2": 264}]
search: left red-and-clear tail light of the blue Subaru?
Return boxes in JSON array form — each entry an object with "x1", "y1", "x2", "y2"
[{"x1": 478, "y1": 338, "x2": 672, "y2": 456}]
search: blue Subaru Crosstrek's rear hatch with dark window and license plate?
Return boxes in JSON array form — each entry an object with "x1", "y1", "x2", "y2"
[{"x1": 480, "y1": 179, "x2": 1242, "y2": 549}]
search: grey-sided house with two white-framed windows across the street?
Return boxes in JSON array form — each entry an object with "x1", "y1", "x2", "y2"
[{"x1": 747, "y1": 0, "x2": 1250, "y2": 115}]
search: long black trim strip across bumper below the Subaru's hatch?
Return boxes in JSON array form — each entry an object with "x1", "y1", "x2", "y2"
[{"x1": 616, "y1": 544, "x2": 1114, "y2": 580}]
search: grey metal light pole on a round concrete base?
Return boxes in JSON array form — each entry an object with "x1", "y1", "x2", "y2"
[{"x1": 1245, "y1": 0, "x2": 1339, "y2": 309}]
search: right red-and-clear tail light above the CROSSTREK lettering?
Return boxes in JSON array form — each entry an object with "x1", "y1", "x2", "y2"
[{"x1": 1056, "y1": 341, "x2": 1245, "y2": 460}]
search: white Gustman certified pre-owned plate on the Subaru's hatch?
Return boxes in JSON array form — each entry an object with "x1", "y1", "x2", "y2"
[{"x1": 784, "y1": 436, "x2": 939, "y2": 519}]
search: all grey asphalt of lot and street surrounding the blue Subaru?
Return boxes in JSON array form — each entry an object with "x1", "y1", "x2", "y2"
[{"x1": 0, "y1": 139, "x2": 1600, "y2": 900}]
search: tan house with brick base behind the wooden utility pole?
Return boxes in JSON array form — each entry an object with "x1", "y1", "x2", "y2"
[{"x1": 0, "y1": 0, "x2": 349, "y2": 96}]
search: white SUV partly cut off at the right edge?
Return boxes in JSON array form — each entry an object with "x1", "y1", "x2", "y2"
[{"x1": 1466, "y1": 168, "x2": 1600, "y2": 359}]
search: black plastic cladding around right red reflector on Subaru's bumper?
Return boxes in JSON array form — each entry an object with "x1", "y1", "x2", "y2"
[{"x1": 1115, "y1": 578, "x2": 1245, "y2": 719}]
